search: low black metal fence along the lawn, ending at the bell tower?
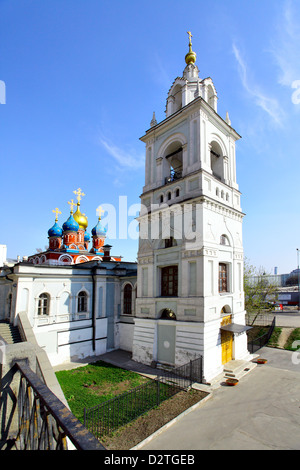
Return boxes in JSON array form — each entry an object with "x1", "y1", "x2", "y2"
[{"x1": 84, "y1": 357, "x2": 202, "y2": 438}]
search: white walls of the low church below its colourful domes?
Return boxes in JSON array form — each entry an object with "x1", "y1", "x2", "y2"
[{"x1": 0, "y1": 261, "x2": 136, "y2": 365}]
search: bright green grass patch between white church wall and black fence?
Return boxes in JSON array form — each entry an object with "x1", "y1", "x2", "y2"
[{"x1": 56, "y1": 361, "x2": 148, "y2": 422}]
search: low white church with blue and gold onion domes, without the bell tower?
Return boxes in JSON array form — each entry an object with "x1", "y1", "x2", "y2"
[{"x1": 0, "y1": 188, "x2": 137, "y2": 365}]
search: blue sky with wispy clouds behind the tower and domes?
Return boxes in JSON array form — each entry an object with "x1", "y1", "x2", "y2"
[{"x1": 0, "y1": 0, "x2": 300, "y2": 273}]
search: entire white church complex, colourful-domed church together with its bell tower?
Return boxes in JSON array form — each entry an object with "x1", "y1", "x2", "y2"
[{"x1": 0, "y1": 32, "x2": 250, "y2": 382}]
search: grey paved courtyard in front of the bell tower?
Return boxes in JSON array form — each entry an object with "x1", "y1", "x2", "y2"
[{"x1": 142, "y1": 347, "x2": 300, "y2": 450}]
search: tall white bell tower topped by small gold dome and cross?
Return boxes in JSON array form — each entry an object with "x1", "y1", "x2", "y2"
[{"x1": 133, "y1": 32, "x2": 249, "y2": 380}]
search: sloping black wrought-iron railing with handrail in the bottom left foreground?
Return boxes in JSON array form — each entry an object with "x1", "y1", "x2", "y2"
[{"x1": 15, "y1": 361, "x2": 105, "y2": 450}]
